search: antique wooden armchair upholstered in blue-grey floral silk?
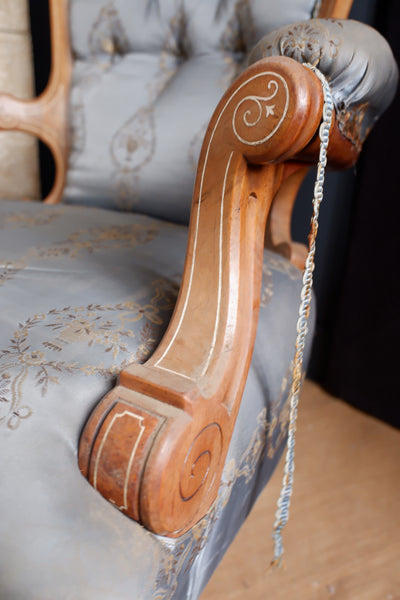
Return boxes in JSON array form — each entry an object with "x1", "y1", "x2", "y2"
[{"x1": 0, "y1": 0, "x2": 397, "y2": 600}]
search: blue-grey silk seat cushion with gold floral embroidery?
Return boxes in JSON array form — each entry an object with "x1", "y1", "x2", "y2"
[{"x1": 0, "y1": 201, "x2": 312, "y2": 600}]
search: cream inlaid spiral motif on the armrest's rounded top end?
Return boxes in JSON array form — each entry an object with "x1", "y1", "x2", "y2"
[{"x1": 232, "y1": 73, "x2": 289, "y2": 146}]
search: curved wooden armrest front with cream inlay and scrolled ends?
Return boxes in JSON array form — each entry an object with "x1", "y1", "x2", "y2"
[{"x1": 79, "y1": 57, "x2": 356, "y2": 536}]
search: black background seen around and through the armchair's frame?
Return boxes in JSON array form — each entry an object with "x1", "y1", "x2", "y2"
[{"x1": 30, "y1": 0, "x2": 400, "y2": 427}]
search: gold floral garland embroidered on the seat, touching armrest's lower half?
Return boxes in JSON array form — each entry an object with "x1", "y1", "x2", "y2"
[{"x1": 0, "y1": 279, "x2": 177, "y2": 429}]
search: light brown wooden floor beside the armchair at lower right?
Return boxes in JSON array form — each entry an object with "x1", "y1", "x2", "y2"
[{"x1": 201, "y1": 382, "x2": 400, "y2": 600}]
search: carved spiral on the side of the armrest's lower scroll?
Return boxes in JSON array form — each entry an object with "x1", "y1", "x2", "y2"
[{"x1": 179, "y1": 423, "x2": 222, "y2": 502}]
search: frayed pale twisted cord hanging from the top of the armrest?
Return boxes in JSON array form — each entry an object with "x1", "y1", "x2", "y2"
[{"x1": 272, "y1": 63, "x2": 334, "y2": 566}]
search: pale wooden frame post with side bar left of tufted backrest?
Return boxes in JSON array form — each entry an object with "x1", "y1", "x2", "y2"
[{"x1": 0, "y1": 0, "x2": 72, "y2": 204}]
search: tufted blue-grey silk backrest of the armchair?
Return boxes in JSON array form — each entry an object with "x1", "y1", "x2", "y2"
[{"x1": 64, "y1": 0, "x2": 349, "y2": 222}]
